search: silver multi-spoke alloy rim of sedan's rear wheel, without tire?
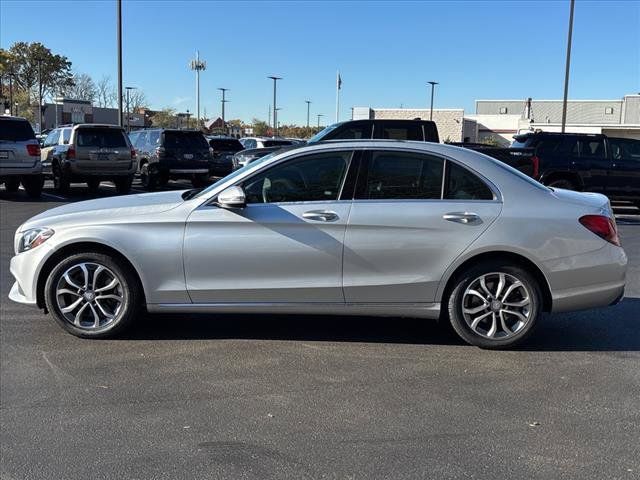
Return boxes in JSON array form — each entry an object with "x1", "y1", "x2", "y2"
[{"x1": 462, "y1": 272, "x2": 532, "y2": 340}]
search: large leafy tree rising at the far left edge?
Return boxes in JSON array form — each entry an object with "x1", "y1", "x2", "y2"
[{"x1": 0, "y1": 42, "x2": 73, "y2": 102}]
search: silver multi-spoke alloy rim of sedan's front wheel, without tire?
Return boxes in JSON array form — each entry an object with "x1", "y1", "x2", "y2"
[{"x1": 55, "y1": 262, "x2": 125, "y2": 330}]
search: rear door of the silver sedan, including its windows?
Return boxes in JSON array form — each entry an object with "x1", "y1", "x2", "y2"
[{"x1": 343, "y1": 150, "x2": 502, "y2": 303}]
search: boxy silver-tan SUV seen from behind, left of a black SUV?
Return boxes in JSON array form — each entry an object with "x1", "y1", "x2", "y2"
[{"x1": 42, "y1": 124, "x2": 137, "y2": 193}]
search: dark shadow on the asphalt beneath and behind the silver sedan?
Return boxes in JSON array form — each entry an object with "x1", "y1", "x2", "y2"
[{"x1": 121, "y1": 298, "x2": 640, "y2": 352}]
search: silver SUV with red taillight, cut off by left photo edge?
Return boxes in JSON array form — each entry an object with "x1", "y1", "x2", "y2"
[{"x1": 0, "y1": 116, "x2": 44, "y2": 198}]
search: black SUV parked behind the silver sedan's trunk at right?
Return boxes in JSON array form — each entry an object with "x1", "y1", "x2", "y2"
[{"x1": 512, "y1": 132, "x2": 640, "y2": 207}]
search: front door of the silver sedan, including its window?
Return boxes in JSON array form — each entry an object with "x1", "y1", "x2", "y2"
[{"x1": 184, "y1": 150, "x2": 353, "y2": 303}]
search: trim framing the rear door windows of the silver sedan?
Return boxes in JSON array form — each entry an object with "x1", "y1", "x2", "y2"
[{"x1": 353, "y1": 147, "x2": 502, "y2": 203}]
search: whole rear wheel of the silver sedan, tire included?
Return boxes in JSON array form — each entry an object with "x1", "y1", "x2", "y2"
[{"x1": 447, "y1": 262, "x2": 542, "y2": 349}]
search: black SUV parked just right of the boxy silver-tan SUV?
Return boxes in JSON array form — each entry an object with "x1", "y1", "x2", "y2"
[{"x1": 129, "y1": 128, "x2": 213, "y2": 190}]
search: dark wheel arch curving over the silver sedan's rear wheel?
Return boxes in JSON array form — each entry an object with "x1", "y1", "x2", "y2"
[{"x1": 440, "y1": 250, "x2": 553, "y2": 312}]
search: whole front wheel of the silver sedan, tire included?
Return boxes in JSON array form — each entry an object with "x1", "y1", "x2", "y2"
[{"x1": 45, "y1": 252, "x2": 141, "y2": 338}]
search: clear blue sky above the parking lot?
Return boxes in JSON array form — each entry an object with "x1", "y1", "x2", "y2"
[{"x1": 0, "y1": 0, "x2": 640, "y2": 124}]
